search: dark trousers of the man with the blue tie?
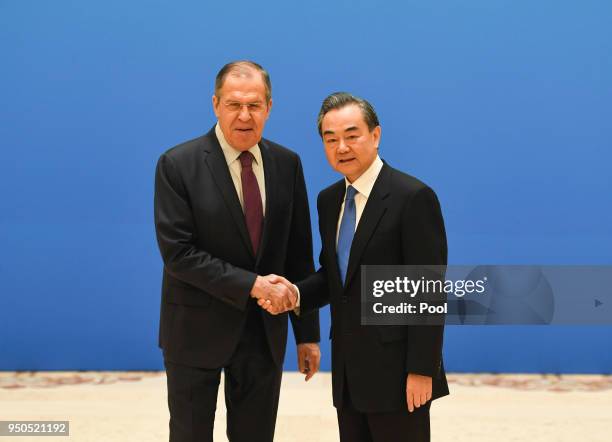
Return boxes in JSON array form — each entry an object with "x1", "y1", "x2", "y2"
[{"x1": 337, "y1": 376, "x2": 431, "y2": 442}]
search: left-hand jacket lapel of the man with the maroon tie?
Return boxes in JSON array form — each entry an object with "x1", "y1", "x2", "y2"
[{"x1": 204, "y1": 128, "x2": 254, "y2": 257}]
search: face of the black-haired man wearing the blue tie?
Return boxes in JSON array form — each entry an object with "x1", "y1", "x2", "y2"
[{"x1": 321, "y1": 104, "x2": 380, "y2": 183}]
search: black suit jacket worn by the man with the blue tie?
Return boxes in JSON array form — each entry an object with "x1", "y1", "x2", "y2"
[{"x1": 298, "y1": 164, "x2": 448, "y2": 413}]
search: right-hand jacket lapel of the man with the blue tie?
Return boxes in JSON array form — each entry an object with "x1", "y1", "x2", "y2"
[{"x1": 344, "y1": 164, "x2": 391, "y2": 287}]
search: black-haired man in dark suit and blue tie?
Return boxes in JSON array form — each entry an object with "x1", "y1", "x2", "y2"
[{"x1": 258, "y1": 93, "x2": 448, "y2": 442}]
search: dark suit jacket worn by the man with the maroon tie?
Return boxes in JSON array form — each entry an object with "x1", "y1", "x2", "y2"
[{"x1": 155, "y1": 128, "x2": 319, "y2": 368}]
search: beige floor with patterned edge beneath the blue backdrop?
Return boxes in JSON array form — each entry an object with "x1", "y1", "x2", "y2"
[{"x1": 0, "y1": 372, "x2": 612, "y2": 442}]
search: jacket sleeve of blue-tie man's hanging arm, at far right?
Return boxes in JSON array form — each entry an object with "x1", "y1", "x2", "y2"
[{"x1": 402, "y1": 187, "x2": 447, "y2": 378}]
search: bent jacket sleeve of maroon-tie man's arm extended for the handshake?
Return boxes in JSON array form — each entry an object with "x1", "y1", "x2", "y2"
[{"x1": 154, "y1": 154, "x2": 257, "y2": 310}]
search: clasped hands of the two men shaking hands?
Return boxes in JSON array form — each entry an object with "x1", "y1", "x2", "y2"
[{"x1": 251, "y1": 274, "x2": 298, "y2": 315}]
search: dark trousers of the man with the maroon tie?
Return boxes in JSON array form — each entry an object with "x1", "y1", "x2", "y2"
[{"x1": 164, "y1": 303, "x2": 282, "y2": 442}]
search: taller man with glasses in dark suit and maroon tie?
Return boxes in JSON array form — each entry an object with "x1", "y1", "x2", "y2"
[{"x1": 155, "y1": 61, "x2": 320, "y2": 442}]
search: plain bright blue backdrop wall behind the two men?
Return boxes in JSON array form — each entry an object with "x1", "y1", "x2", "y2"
[{"x1": 0, "y1": 0, "x2": 612, "y2": 373}]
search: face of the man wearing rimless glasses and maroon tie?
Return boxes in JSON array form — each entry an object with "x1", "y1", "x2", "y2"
[{"x1": 213, "y1": 70, "x2": 272, "y2": 151}]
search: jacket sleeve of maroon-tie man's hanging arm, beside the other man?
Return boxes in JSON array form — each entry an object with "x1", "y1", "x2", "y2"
[{"x1": 285, "y1": 157, "x2": 320, "y2": 344}]
